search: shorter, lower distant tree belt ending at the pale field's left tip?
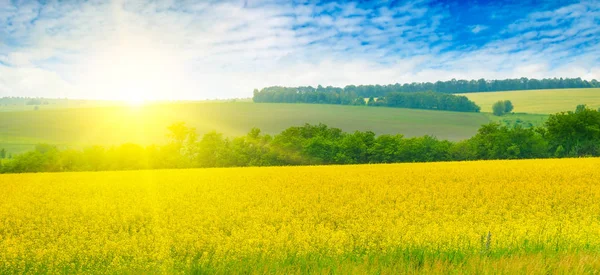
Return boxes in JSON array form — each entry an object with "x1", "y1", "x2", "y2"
[{"x1": 253, "y1": 87, "x2": 481, "y2": 112}]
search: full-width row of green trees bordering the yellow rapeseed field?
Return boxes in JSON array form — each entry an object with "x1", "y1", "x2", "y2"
[{"x1": 0, "y1": 105, "x2": 600, "y2": 173}]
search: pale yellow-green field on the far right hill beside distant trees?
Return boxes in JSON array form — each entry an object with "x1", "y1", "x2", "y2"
[{"x1": 461, "y1": 88, "x2": 600, "y2": 114}]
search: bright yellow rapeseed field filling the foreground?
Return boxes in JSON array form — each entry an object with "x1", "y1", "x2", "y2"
[{"x1": 0, "y1": 158, "x2": 600, "y2": 274}]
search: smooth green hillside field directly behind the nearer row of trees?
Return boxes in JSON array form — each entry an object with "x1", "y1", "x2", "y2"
[{"x1": 0, "y1": 102, "x2": 490, "y2": 153}]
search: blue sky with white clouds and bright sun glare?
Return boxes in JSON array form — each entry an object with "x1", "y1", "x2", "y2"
[{"x1": 0, "y1": 0, "x2": 600, "y2": 99}]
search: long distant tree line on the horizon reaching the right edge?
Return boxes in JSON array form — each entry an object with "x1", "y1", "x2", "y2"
[{"x1": 254, "y1": 77, "x2": 600, "y2": 104}]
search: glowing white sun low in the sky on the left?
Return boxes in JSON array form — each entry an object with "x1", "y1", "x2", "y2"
[{"x1": 79, "y1": 37, "x2": 190, "y2": 106}]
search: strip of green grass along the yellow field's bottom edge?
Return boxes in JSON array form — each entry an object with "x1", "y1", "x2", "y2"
[{"x1": 5, "y1": 248, "x2": 600, "y2": 274}]
